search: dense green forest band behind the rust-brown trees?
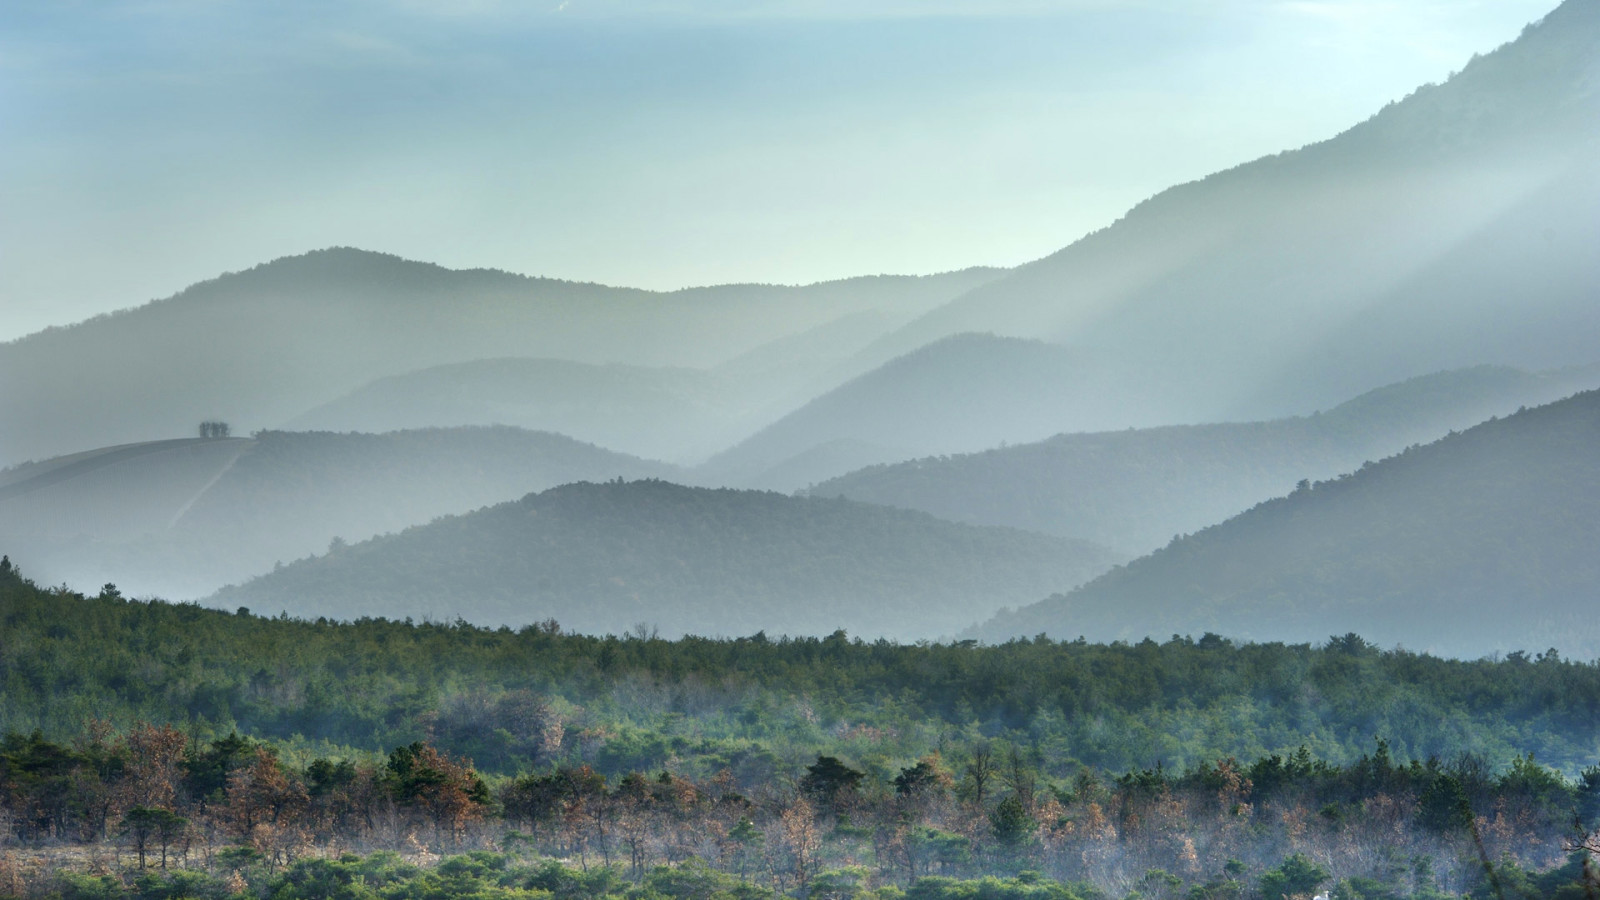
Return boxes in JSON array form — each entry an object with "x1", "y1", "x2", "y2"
[{"x1": 0, "y1": 564, "x2": 1600, "y2": 771}]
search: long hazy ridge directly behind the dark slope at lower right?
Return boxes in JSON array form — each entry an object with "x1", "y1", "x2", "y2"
[{"x1": 805, "y1": 365, "x2": 1600, "y2": 554}]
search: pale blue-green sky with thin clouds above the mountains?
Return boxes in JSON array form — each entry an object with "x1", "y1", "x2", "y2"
[{"x1": 0, "y1": 0, "x2": 1555, "y2": 341}]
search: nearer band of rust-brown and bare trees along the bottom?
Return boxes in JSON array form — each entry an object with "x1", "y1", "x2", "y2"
[{"x1": 0, "y1": 725, "x2": 1600, "y2": 900}]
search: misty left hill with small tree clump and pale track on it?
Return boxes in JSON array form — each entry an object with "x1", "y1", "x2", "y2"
[{"x1": 0, "y1": 428, "x2": 674, "y2": 597}]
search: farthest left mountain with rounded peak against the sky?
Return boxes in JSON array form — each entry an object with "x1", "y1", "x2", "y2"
[{"x1": 0, "y1": 248, "x2": 998, "y2": 463}]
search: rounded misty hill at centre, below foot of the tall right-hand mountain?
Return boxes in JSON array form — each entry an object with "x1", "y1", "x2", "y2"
[{"x1": 698, "y1": 335, "x2": 1115, "y2": 490}]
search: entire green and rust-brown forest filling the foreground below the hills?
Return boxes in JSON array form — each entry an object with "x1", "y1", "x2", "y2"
[{"x1": 0, "y1": 560, "x2": 1600, "y2": 900}]
